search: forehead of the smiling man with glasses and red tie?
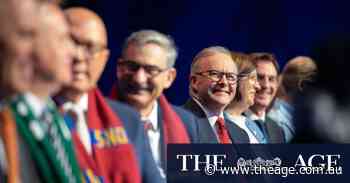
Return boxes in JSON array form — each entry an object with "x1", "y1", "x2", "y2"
[{"x1": 197, "y1": 53, "x2": 237, "y2": 73}]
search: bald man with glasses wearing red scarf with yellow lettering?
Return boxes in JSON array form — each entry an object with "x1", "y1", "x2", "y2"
[{"x1": 57, "y1": 8, "x2": 164, "y2": 183}]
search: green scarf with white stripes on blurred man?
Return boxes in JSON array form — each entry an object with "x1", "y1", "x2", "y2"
[{"x1": 10, "y1": 95, "x2": 82, "y2": 183}]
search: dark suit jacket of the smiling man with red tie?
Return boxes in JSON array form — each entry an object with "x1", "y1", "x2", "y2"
[{"x1": 183, "y1": 98, "x2": 249, "y2": 144}]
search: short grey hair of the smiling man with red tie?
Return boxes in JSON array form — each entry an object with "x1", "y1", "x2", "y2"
[{"x1": 191, "y1": 46, "x2": 231, "y2": 75}]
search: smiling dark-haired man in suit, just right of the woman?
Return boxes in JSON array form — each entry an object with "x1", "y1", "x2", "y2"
[{"x1": 245, "y1": 53, "x2": 285, "y2": 143}]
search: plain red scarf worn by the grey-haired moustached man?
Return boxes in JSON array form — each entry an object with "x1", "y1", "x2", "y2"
[{"x1": 110, "y1": 86, "x2": 190, "y2": 144}]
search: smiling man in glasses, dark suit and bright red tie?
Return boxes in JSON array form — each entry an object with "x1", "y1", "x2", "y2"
[{"x1": 183, "y1": 46, "x2": 249, "y2": 143}]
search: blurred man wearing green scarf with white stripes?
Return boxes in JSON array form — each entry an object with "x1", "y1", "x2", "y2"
[{"x1": 1, "y1": 1, "x2": 81, "y2": 183}]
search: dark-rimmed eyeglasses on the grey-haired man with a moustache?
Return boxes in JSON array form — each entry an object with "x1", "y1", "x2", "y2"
[{"x1": 118, "y1": 60, "x2": 168, "y2": 77}]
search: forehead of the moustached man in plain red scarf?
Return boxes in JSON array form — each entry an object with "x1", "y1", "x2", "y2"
[{"x1": 123, "y1": 43, "x2": 167, "y2": 68}]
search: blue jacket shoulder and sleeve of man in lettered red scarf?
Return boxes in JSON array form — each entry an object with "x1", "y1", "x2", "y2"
[{"x1": 106, "y1": 99, "x2": 166, "y2": 183}]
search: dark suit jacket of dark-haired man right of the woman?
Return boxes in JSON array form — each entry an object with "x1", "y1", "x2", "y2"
[{"x1": 264, "y1": 117, "x2": 286, "y2": 143}]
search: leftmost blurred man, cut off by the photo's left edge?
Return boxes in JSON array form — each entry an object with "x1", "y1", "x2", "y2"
[{"x1": 0, "y1": 0, "x2": 38, "y2": 182}]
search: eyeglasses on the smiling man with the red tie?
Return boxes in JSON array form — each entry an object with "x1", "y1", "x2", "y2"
[{"x1": 196, "y1": 70, "x2": 238, "y2": 83}]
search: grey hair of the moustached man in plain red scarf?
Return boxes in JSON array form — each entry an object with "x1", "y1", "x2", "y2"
[{"x1": 122, "y1": 30, "x2": 178, "y2": 68}]
